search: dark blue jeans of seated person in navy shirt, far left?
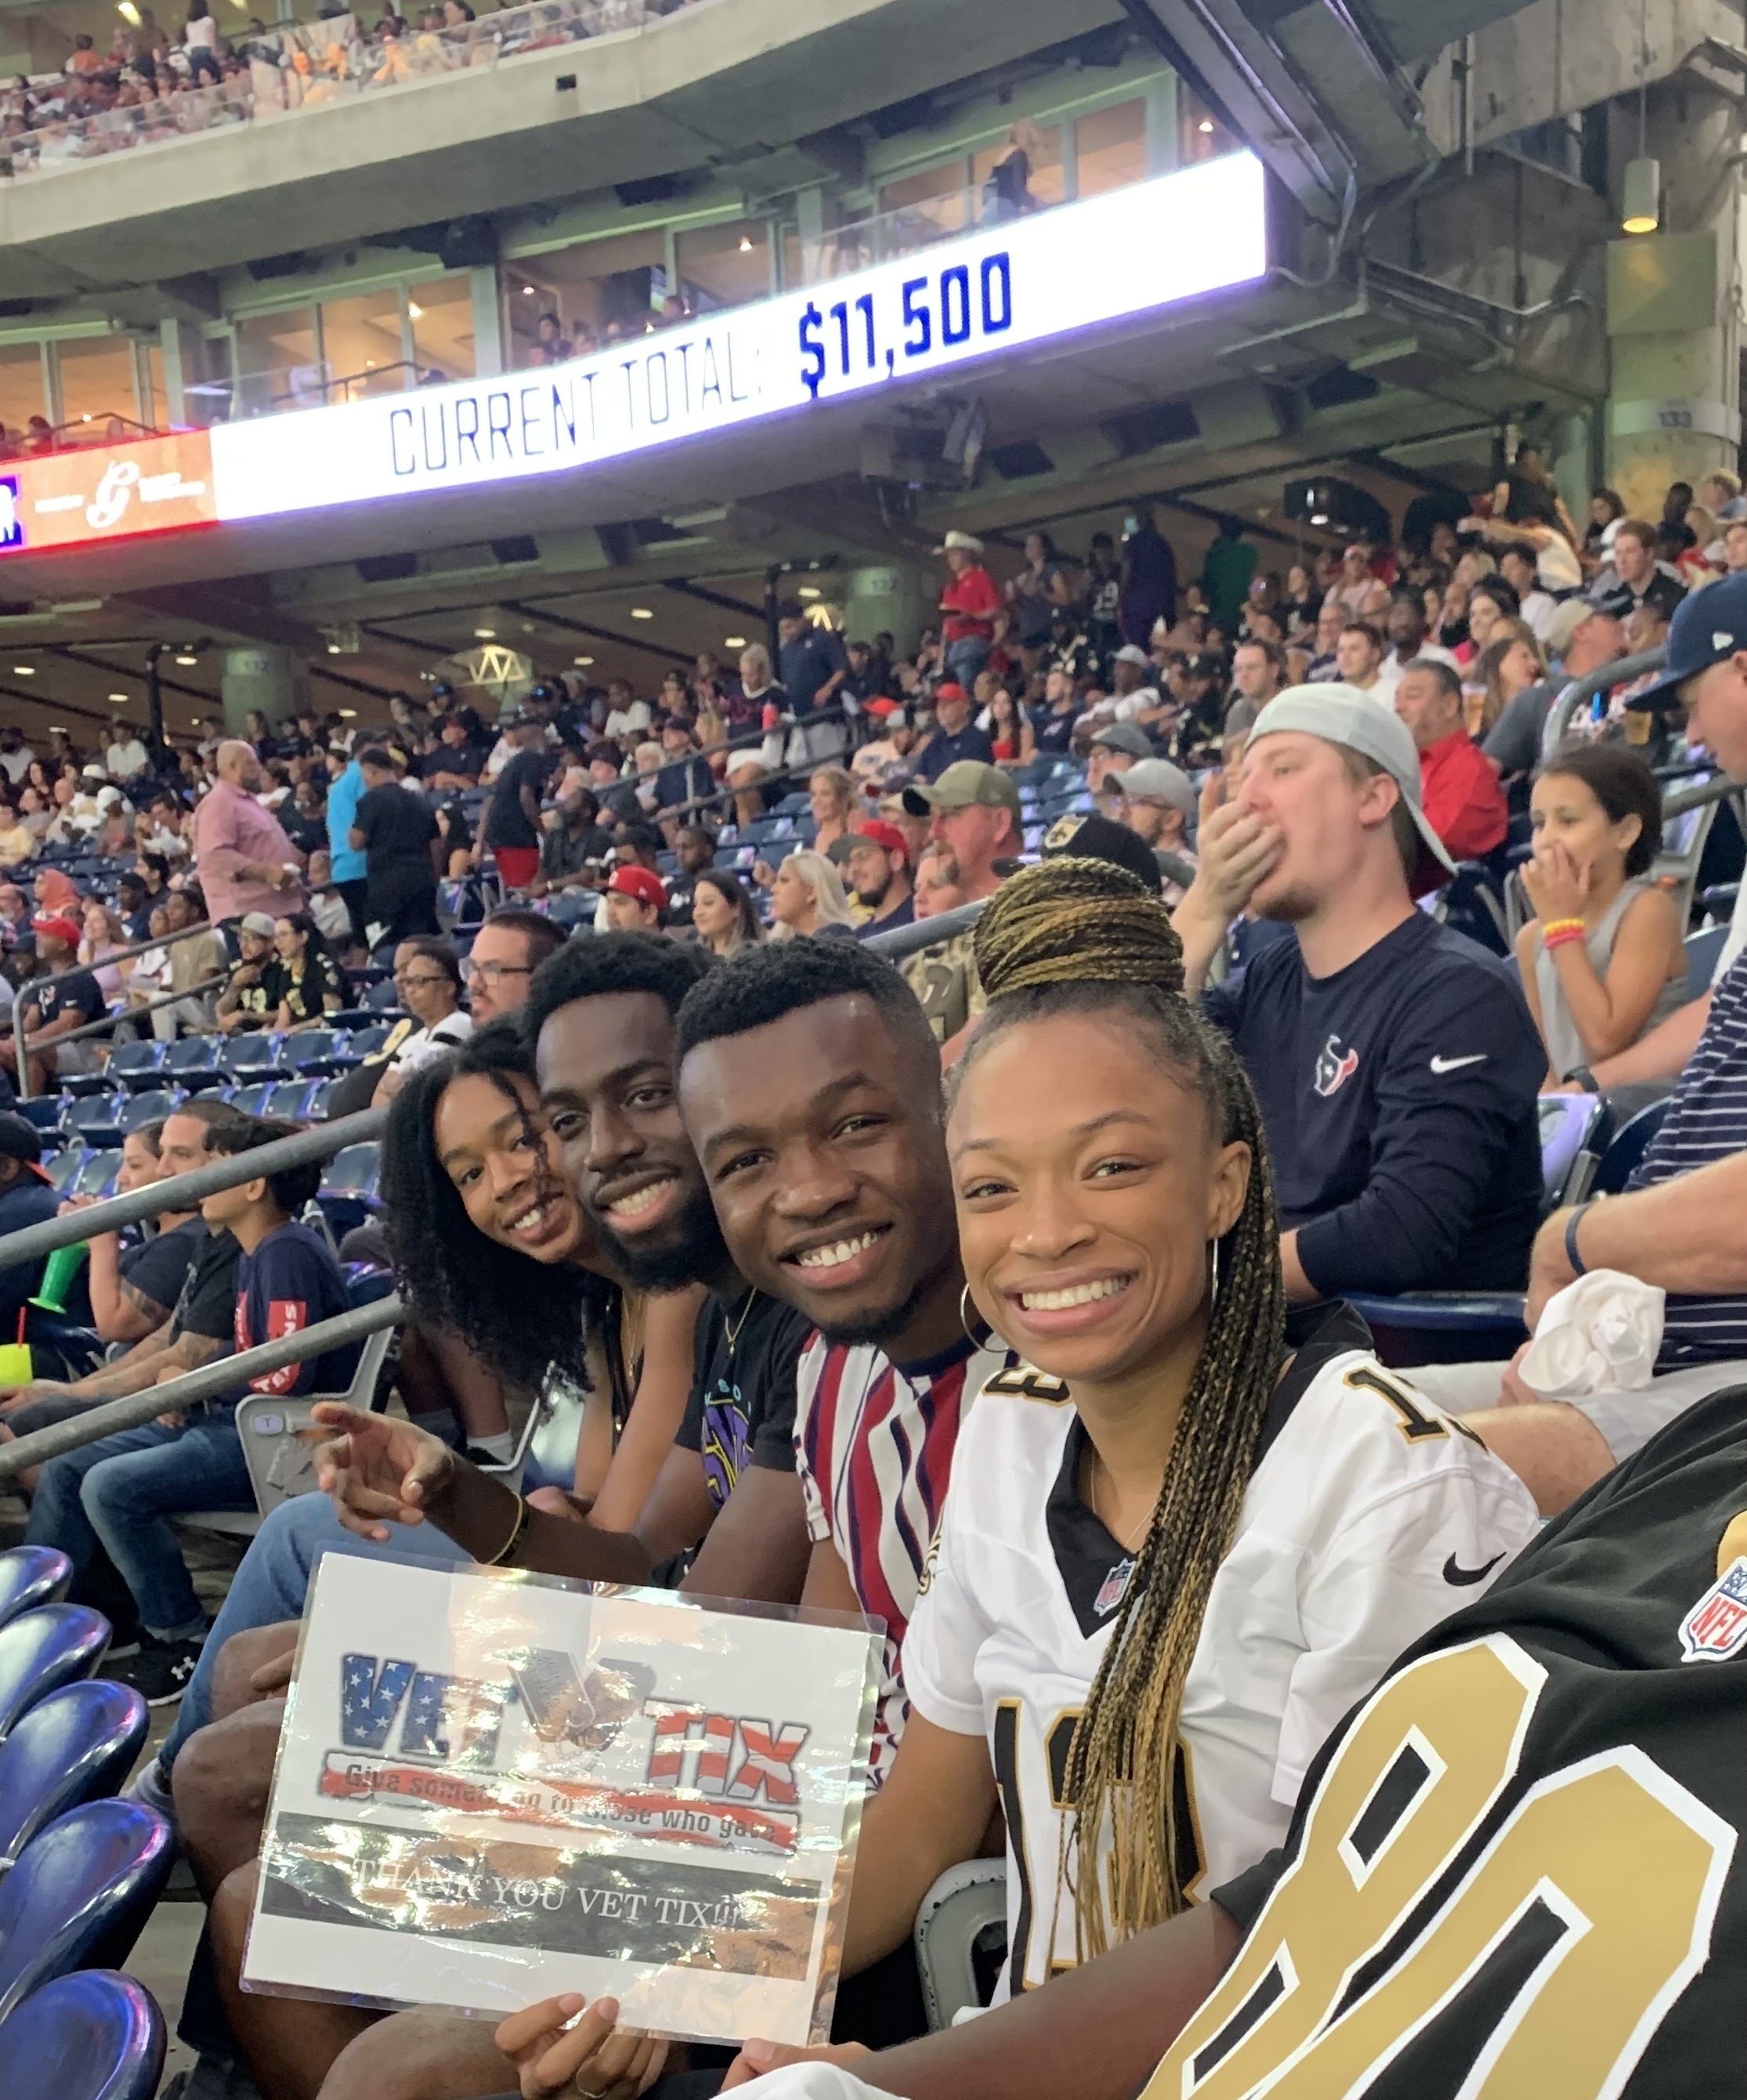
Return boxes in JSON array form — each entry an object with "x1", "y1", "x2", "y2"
[{"x1": 25, "y1": 1409, "x2": 254, "y2": 1640}]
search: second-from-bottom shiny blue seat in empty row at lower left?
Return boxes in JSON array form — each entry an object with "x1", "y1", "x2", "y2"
[{"x1": 0, "y1": 1801, "x2": 176, "y2": 2020}]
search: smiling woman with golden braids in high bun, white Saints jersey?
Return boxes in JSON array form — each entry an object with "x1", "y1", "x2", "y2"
[{"x1": 722, "y1": 859, "x2": 1535, "y2": 2090}]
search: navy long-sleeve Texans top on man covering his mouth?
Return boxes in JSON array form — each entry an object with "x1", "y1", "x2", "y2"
[{"x1": 1203, "y1": 911, "x2": 1547, "y2": 1298}]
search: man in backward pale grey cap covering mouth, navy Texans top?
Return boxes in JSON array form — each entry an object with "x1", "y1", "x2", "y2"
[{"x1": 1174, "y1": 682, "x2": 1546, "y2": 1304}]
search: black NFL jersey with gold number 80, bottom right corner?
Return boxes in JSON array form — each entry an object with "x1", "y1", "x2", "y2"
[{"x1": 1201, "y1": 1386, "x2": 1747, "y2": 2100}]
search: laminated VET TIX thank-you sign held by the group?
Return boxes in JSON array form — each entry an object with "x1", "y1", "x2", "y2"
[{"x1": 244, "y1": 1554, "x2": 880, "y2": 2044}]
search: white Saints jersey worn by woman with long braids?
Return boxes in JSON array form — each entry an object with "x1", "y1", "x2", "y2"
[{"x1": 903, "y1": 1306, "x2": 1537, "y2": 1997}]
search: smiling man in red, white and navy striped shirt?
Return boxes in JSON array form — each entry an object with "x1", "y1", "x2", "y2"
[{"x1": 678, "y1": 941, "x2": 1008, "y2": 1781}]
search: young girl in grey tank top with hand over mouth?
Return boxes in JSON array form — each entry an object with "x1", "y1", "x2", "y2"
[{"x1": 1516, "y1": 744, "x2": 1686, "y2": 1084}]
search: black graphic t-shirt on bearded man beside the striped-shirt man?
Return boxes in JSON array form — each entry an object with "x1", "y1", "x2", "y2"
[{"x1": 674, "y1": 1291, "x2": 812, "y2": 1510}]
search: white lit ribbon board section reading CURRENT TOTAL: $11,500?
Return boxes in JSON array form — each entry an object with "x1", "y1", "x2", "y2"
[{"x1": 210, "y1": 154, "x2": 1266, "y2": 521}]
